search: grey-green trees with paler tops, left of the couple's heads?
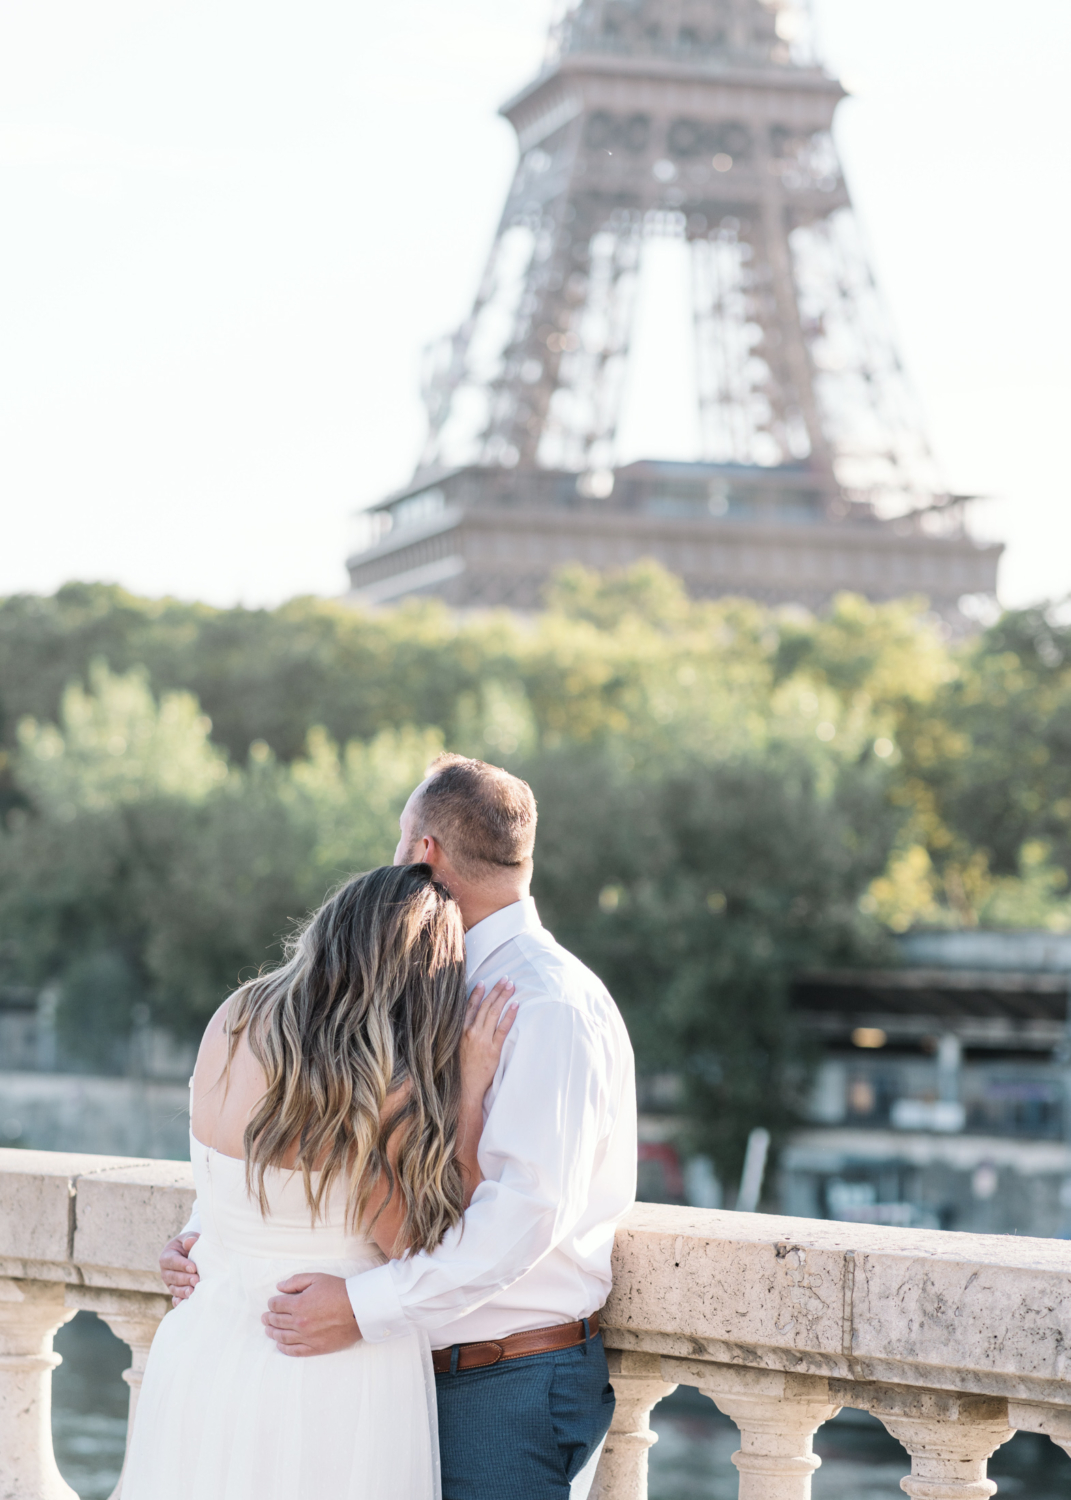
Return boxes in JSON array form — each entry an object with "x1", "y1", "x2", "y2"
[{"x1": 0, "y1": 663, "x2": 440, "y2": 1065}]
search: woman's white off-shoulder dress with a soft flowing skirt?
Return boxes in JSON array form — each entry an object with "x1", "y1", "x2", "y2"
[{"x1": 123, "y1": 1137, "x2": 440, "y2": 1500}]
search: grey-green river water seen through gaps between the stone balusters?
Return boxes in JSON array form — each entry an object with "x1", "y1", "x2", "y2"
[{"x1": 53, "y1": 1313, "x2": 1071, "y2": 1500}]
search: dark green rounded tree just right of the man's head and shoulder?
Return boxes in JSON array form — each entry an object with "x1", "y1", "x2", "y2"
[{"x1": 527, "y1": 749, "x2": 897, "y2": 1172}]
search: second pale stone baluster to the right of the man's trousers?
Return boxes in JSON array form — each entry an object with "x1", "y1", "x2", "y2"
[{"x1": 693, "y1": 1361, "x2": 840, "y2": 1500}]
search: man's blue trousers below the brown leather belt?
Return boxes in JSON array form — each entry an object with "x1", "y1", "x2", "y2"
[{"x1": 435, "y1": 1335, "x2": 614, "y2": 1500}]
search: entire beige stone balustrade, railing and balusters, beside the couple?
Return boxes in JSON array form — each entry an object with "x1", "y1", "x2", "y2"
[{"x1": 0, "y1": 1151, "x2": 1071, "y2": 1500}]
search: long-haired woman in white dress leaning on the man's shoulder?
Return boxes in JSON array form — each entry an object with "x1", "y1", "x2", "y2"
[{"x1": 123, "y1": 864, "x2": 516, "y2": 1500}]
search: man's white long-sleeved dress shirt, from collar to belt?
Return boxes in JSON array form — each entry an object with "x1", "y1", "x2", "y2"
[{"x1": 347, "y1": 899, "x2": 636, "y2": 1349}]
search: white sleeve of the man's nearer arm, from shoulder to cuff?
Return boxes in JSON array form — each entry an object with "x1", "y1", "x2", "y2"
[{"x1": 347, "y1": 999, "x2": 609, "y2": 1344}]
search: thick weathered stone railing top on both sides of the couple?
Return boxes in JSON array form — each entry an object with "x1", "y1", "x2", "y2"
[{"x1": 0, "y1": 1151, "x2": 1071, "y2": 1407}]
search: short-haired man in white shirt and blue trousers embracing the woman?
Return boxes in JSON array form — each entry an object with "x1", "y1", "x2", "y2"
[{"x1": 161, "y1": 756, "x2": 636, "y2": 1500}]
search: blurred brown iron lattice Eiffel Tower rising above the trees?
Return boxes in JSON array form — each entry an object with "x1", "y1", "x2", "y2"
[{"x1": 348, "y1": 0, "x2": 1002, "y2": 617}]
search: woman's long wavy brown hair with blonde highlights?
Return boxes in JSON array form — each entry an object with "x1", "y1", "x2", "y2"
[{"x1": 228, "y1": 864, "x2": 467, "y2": 1251}]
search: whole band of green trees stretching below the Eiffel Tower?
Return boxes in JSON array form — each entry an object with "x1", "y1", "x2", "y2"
[{"x1": 0, "y1": 564, "x2": 1071, "y2": 1172}]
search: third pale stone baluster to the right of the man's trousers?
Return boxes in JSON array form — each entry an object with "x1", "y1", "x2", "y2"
[{"x1": 852, "y1": 1386, "x2": 1016, "y2": 1500}]
